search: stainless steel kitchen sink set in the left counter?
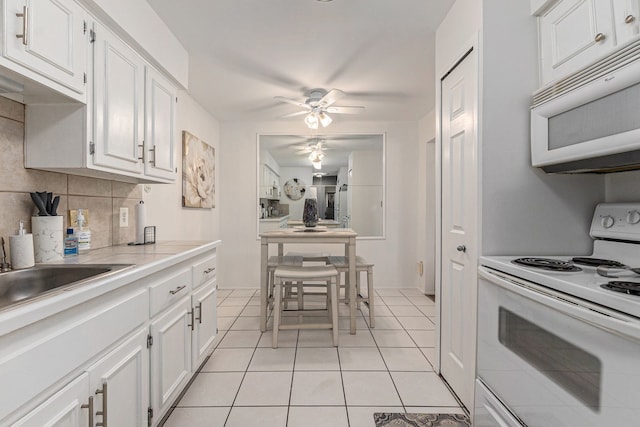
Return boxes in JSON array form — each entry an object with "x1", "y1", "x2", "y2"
[{"x1": 0, "y1": 264, "x2": 133, "y2": 310}]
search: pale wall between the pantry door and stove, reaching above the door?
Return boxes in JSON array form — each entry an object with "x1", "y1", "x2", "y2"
[{"x1": 436, "y1": 0, "x2": 605, "y2": 255}]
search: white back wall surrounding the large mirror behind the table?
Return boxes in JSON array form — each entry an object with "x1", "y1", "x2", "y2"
[{"x1": 219, "y1": 118, "x2": 422, "y2": 288}]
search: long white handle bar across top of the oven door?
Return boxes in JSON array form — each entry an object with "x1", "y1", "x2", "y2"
[{"x1": 478, "y1": 266, "x2": 640, "y2": 341}]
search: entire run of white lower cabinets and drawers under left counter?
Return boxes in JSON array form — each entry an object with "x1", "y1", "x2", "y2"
[{"x1": 0, "y1": 246, "x2": 217, "y2": 427}]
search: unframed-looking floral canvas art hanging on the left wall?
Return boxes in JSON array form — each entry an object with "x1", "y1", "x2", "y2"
[{"x1": 182, "y1": 130, "x2": 216, "y2": 209}]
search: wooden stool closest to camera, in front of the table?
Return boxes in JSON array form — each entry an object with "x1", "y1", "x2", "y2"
[{"x1": 271, "y1": 265, "x2": 339, "y2": 348}]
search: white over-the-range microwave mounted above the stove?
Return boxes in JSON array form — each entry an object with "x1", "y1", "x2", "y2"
[{"x1": 531, "y1": 46, "x2": 640, "y2": 173}]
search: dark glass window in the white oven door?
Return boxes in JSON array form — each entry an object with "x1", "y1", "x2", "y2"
[{"x1": 498, "y1": 307, "x2": 602, "y2": 412}]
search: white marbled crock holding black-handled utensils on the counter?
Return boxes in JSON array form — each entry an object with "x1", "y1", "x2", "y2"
[{"x1": 31, "y1": 215, "x2": 64, "y2": 262}]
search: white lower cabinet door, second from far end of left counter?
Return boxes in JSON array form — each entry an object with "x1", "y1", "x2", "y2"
[{"x1": 150, "y1": 297, "x2": 194, "y2": 419}]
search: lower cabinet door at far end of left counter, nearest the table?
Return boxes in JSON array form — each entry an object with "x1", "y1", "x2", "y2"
[{"x1": 191, "y1": 280, "x2": 217, "y2": 371}]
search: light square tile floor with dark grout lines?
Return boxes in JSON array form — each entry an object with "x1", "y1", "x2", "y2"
[{"x1": 159, "y1": 289, "x2": 463, "y2": 427}]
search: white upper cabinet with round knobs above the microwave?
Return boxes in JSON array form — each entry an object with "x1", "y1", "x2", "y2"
[{"x1": 532, "y1": 0, "x2": 640, "y2": 86}]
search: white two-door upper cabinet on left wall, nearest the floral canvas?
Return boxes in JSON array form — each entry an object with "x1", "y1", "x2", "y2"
[{"x1": 25, "y1": 16, "x2": 177, "y2": 183}]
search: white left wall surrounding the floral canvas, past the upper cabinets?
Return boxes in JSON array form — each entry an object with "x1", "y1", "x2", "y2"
[{"x1": 143, "y1": 91, "x2": 221, "y2": 244}]
